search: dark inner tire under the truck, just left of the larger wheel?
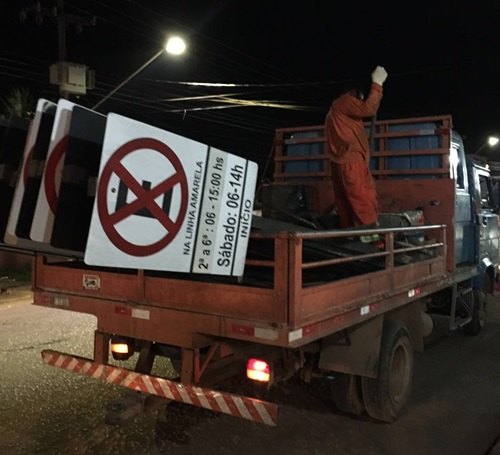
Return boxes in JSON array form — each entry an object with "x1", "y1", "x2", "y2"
[{"x1": 329, "y1": 373, "x2": 365, "y2": 415}]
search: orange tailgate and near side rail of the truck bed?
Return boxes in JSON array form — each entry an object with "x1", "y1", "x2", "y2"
[{"x1": 34, "y1": 226, "x2": 447, "y2": 347}]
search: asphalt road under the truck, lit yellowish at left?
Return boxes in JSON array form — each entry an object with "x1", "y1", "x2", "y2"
[{"x1": 0, "y1": 291, "x2": 500, "y2": 455}]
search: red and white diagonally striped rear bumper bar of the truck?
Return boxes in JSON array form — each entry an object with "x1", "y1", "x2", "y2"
[{"x1": 42, "y1": 350, "x2": 278, "y2": 426}]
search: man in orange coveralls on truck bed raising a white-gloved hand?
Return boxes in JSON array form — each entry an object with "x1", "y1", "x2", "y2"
[{"x1": 325, "y1": 66, "x2": 387, "y2": 228}]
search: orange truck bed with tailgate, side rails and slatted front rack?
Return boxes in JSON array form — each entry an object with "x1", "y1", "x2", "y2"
[{"x1": 34, "y1": 116, "x2": 488, "y2": 347}]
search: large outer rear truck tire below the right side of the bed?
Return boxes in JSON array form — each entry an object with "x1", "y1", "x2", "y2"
[{"x1": 361, "y1": 319, "x2": 413, "y2": 422}]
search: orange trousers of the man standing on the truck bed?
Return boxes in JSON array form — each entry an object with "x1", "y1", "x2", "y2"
[{"x1": 332, "y1": 160, "x2": 378, "y2": 228}]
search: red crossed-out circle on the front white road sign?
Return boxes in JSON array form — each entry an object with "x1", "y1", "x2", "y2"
[{"x1": 97, "y1": 138, "x2": 188, "y2": 256}]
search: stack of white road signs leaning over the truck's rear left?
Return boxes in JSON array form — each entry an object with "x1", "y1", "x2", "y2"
[{"x1": 0, "y1": 99, "x2": 257, "y2": 276}]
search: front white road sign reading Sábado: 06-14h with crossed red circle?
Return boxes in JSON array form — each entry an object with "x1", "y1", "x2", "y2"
[{"x1": 85, "y1": 114, "x2": 257, "y2": 276}]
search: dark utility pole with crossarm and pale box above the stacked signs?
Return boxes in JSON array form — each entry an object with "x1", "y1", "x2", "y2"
[{"x1": 19, "y1": 0, "x2": 96, "y2": 98}]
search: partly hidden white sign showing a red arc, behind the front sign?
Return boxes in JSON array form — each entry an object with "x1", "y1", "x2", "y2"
[{"x1": 30, "y1": 99, "x2": 75, "y2": 243}]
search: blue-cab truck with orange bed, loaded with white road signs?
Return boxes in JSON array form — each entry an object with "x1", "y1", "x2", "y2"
[{"x1": 3, "y1": 108, "x2": 499, "y2": 425}]
